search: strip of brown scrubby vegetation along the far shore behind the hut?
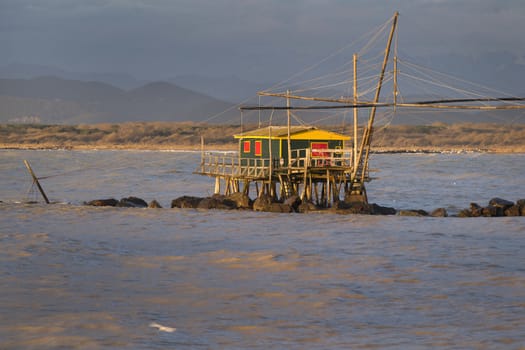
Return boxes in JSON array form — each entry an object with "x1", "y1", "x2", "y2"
[{"x1": 0, "y1": 122, "x2": 525, "y2": 153}]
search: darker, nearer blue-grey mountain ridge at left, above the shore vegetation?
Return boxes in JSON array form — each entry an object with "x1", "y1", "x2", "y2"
[{"x1": 0, "y1": 77, "x2": 233, "y2": 124}]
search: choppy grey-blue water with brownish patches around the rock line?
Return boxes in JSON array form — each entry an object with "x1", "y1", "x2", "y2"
[{"x1": 0, "y1": 150, "x2": 525, "y2": 349}]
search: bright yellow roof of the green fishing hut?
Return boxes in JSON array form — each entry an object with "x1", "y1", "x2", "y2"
[{"x1": 233, "y1": 126, "x2": 350, "y2": 141}]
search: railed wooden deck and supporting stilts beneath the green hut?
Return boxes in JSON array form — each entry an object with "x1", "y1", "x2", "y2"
[{"x1": 194, "y1": 149, "x2": 368, "y2": 206}]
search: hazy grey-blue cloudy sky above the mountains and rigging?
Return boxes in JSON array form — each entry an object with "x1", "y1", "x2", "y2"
[{"x1": 0, "y1": 0, "x2": 525, "y2": 81}]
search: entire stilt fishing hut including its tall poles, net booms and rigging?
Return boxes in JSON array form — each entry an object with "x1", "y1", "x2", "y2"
[{"x1": 196, "y1": 12, "x2": 525, "y2": 207}]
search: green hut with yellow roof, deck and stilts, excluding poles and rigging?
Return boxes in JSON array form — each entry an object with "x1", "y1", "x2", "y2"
[{"x1": 197, "y1": 126, "x2": 353, "y2": 207}]
